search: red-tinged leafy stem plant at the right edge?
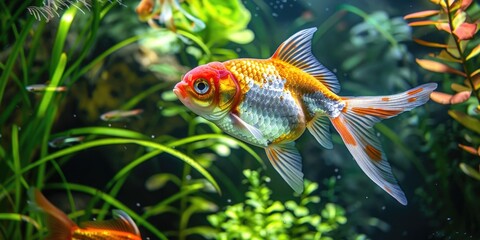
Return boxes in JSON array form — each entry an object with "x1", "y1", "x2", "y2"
[{"x1": 404, "y1": 0, "x2": 480, "y2": 180}]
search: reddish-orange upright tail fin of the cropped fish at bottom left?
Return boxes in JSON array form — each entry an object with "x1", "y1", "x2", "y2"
[{"x1": 29, "y1": 188, "x2": 77, "y2": 240}]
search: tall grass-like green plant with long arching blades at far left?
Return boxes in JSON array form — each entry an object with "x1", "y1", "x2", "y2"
[{"x1": 0, "y1": 1, "x2": 227, "y2": 239}]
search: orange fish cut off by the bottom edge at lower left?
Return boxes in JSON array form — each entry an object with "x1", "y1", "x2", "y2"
[{"x1": 29, "y1": 189, "x2": 142, "y2": 240}]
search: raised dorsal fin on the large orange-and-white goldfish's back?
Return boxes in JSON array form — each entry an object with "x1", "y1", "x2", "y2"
[{"x1": 272, "y1": 28, "x2": 340, "y2": 93}]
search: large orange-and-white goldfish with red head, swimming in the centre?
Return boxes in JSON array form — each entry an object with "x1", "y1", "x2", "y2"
[{"x1": 173, "y1": 28, "x2": 437, "y2": 205}]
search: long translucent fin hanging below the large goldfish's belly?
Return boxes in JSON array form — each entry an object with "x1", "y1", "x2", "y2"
[{"x1": 265, "y1": 142, "x2": 303, "y2": 193}]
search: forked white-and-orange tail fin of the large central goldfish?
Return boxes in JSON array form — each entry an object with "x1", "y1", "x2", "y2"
[{"x1": 330, "y1": 83, "x2": 437, "y2": 205}]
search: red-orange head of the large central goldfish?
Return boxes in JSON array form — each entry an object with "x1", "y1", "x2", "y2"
[{"x1": 173, "y1": 62, "x2": 241, "y2": 120}]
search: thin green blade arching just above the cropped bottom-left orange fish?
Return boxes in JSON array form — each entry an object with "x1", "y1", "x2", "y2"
[{"x1": 48, "y1": 183, "x2": 167, "y2": 240}]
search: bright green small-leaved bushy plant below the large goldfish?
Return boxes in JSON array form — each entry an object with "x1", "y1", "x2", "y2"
[{"x1": 208, "y1": 170, "x2": 364, "y2": 239}]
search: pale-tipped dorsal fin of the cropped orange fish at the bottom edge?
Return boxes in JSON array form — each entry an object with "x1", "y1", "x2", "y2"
[{"x1": 80, "y1": 210, "x2": 140, "y2": 236}]
